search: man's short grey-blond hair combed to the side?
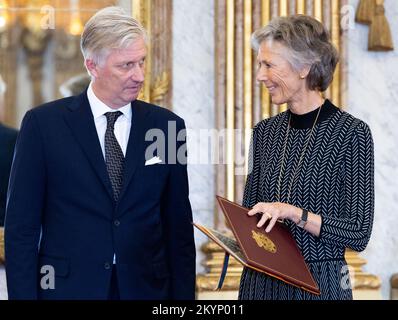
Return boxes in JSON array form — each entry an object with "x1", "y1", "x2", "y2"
[{"x1": 80, "y1": 6, "x2": 147, "y2": 64}]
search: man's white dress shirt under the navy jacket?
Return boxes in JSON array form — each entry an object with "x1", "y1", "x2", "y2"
[{"x1": 87, "y1": 83, "x2": 132, "y2": 264}]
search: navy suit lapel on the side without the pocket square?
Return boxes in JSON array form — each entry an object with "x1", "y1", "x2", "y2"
[{"x1": 65, "y1": 91, "x2": 113, "y2": 200}]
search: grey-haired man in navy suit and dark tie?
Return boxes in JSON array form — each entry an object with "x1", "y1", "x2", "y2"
[{"x1": 5, "y1": 7, "x2": 195, "y2": 299}]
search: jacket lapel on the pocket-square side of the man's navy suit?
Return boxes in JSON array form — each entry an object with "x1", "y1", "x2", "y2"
[{"x1": 119, "y1": 100, "x2": 151, "y2": 200}]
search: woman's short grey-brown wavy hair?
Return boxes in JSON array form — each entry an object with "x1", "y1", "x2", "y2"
[{"x1": 252, "y1": 15, "x2": 339, "y2": 91}]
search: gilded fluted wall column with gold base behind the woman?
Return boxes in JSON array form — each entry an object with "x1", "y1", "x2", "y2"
[{"x1": 197, "y1": 0, "x2": 380, "y2": 298}]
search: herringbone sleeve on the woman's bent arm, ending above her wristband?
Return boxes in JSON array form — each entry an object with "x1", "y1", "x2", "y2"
[{"x1": 319, "y1": 122, "x2": 375, "y2": 251}]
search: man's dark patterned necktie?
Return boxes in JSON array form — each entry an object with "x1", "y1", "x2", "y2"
[{"x1": 105, "y1": 111, "x2": 124, "y2": 201}]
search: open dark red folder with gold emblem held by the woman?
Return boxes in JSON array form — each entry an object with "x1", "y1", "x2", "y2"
[{"x1": 194, "y1": 196, "x2": 320, "y2": 295}]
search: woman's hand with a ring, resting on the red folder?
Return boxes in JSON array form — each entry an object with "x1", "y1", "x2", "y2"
[{"x1": 248, "y1": 202, "x2": 302, "y2": 232}]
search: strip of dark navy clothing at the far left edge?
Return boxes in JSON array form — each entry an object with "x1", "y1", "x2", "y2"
[{"x1": 0, "y1": 123, "x2": 18, "y2": 226}]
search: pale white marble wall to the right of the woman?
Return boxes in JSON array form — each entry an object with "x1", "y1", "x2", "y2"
[{"x1": 346, "y1": 0, "x2": 398, "y2": 299}]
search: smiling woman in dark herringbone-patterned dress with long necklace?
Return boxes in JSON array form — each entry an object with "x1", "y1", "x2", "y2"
[{"x1": 239, "y1": 15, "x2": 374, "y2": 300}]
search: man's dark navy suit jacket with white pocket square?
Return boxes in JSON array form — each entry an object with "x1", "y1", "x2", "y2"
[{"x1": 5, "y1": 92, "x2": 195, "y2": 300}]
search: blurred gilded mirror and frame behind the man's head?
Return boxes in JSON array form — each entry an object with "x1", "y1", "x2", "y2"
[{"x1": 0, "y1": 0, "x2": 172, "y2": 127}]
